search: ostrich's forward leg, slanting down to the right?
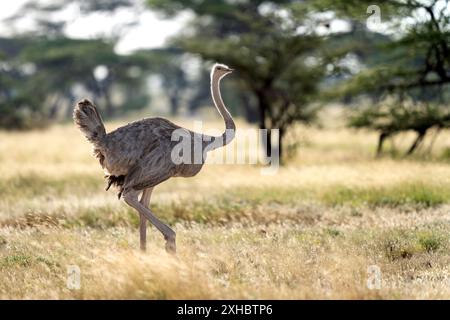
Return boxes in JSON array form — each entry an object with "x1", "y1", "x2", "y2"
[{"x1": 123, "y1": 190, "x2": 176, "y2": 253}]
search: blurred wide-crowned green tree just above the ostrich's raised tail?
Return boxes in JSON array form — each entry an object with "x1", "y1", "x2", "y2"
[{"x1": 19, "y1": 37, "x2": 152, "y2": 117}]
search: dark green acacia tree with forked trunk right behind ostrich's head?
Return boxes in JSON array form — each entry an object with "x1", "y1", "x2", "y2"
[{"x1": 147, "y1": 0, "x2": 325, "y2": 160}]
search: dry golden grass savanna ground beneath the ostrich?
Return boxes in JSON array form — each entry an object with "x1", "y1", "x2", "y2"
[{"x1": 0, "y1": 110, "x2": 450, "y2": 299}]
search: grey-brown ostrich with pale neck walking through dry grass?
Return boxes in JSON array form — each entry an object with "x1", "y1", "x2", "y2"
[{"x1": 73, "y1": 64, "x2": 236, "y2": 254}]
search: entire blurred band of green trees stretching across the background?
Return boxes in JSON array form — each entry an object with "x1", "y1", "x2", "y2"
[{"x1": 0, "y1": 0, "x2": 450, "y2": 160}]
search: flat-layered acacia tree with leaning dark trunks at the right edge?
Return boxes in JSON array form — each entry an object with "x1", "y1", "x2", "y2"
[{"x1": 315, "y1": 0, "x2": 450, "y2": 154}]
